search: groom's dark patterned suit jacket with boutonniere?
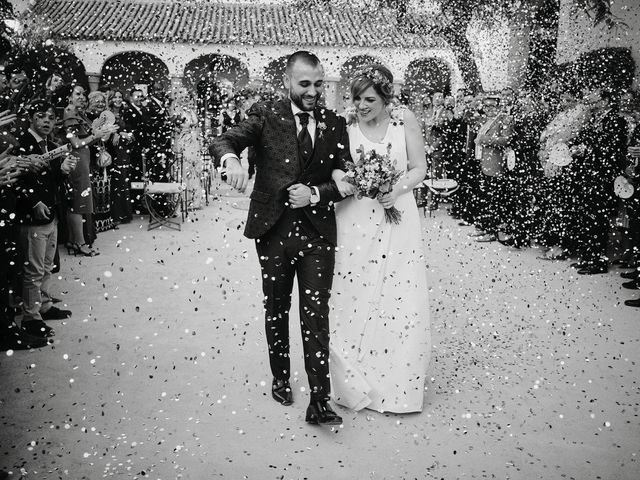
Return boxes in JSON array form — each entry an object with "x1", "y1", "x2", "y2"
[{"x1": 211, "y1": 99, "x2": 351, "y2": 245}]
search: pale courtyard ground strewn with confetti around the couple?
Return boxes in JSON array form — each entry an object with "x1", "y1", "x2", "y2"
[{"x1": 0, "y1": 182, "x2": 640, "y2": 480}]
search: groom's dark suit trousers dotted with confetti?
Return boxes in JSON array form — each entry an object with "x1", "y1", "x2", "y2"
[{"x1": 256, "y1": 219, "x2": 335, "y2": 400}]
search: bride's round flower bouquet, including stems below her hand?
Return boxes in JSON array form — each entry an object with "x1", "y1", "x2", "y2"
[{"x1": 343, "y1": 144, "x2": 404, "y2": 225}]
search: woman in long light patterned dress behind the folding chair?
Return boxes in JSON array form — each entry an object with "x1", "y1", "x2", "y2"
[{"x1": 171, "y1": 88, "x2": 204, "y2": 210}]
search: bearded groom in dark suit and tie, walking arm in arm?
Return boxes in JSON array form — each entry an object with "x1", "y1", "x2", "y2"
[{"x1": 212, "y1": 51, "x2": 350, "y2": 425}]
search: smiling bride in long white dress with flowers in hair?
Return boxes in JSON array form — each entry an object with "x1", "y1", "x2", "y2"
[{"x1": 330, "y1": 65, "x2": 431, "y2": 413}]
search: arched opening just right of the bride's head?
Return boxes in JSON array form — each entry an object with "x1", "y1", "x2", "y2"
[{"x1": 403, "y1": 58, "x2": 451, "y2": 104}]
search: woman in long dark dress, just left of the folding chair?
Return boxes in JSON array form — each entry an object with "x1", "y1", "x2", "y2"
[{"x1": 107, "y1": 90, "x2": 133, "y2": 224}]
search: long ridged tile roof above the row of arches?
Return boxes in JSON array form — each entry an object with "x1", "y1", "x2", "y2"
[{"x1": 36, "y1": 0, "x2": 440, "y2": 48}]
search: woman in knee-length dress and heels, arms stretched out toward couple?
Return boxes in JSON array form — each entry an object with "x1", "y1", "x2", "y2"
[{"x1": 63, "y1": 85, "x2": 117, "y2": 256}]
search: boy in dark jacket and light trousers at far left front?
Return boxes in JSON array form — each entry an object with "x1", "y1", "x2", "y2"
[{"x1": 16, "y1": 101, "x2": 75, "y2": 337}]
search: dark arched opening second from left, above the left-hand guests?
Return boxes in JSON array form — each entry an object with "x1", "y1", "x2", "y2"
[{"x1": 100, "y1": 51, "x2": 170, "y2": 92}]
